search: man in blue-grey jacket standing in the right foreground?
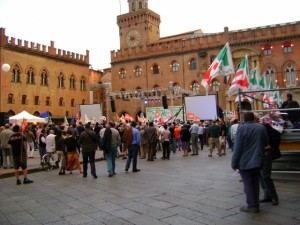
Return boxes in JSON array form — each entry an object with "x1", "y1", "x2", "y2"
[{"x1": 231, "y1": 112, "x2": 269, "y2": 213}]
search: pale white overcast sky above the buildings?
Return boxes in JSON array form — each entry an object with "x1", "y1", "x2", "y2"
[{"x1": 0, "y1": 0, "x2": 300, "y2": 69}]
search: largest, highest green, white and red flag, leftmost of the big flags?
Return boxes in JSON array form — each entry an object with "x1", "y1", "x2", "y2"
[{"x1": 201, "y1": 43, "x2": 234, "y2": 93}]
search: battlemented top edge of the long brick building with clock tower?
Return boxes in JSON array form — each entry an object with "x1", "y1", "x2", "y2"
[{"x1": 111, "y1": 21, "x2": 300, "y2": 63}]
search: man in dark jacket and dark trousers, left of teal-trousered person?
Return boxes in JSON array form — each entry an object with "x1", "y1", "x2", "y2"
[{"x1": 79, "y1": 124, "x2": 98, "y2": 179}]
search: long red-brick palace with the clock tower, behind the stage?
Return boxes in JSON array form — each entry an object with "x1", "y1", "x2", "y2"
[{"x1": 110, "y1": 0, "x2": 300, "y2": 121}]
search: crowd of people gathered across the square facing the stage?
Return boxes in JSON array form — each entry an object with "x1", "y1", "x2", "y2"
[{"x1": 0, "y1": 92, "x2": 298, "y2": 213}]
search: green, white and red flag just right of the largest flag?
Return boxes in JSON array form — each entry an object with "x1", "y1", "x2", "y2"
[{"x1": 228, "y1": 55, "x2": 249, "y2": 96}]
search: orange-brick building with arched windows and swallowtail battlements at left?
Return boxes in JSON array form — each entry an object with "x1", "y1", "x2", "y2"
[{"x1": 0, "y1": 28, "x2": 90, "y2": 123}]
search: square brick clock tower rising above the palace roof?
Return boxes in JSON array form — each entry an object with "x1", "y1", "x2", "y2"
[{"x1": 117, "y1": 0, "x2": 160, "y2": 48}]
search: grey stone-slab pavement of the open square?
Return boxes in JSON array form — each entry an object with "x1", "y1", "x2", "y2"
[{"x1": 0, "y1": 147, "x2": 300, "y2": 225}]
